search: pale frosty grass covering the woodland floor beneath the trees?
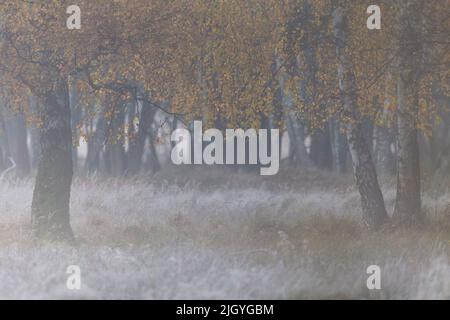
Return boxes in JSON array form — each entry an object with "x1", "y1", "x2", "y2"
[{"x1": 0, "y1": 169, "x2": 450, "y2": 299}]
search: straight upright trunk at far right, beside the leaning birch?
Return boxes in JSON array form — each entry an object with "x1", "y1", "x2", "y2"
[{"x1": 394, "y1": 0, "x2": 424, "y2": 225}]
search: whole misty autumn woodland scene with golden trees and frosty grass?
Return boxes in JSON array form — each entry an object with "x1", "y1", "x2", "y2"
[{"x1": 0, "y1": 0, "x2": 450, "y2": 298}]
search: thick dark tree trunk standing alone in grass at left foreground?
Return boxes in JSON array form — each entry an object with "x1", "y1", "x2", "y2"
[{"x1": 31, "y1": 79, "x2": 73, "y2": 239}]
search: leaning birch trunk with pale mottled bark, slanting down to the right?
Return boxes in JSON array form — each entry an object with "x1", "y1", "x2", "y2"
[{"x1": 333, "y1": 4, "x2": 388, "y2": 230}]
